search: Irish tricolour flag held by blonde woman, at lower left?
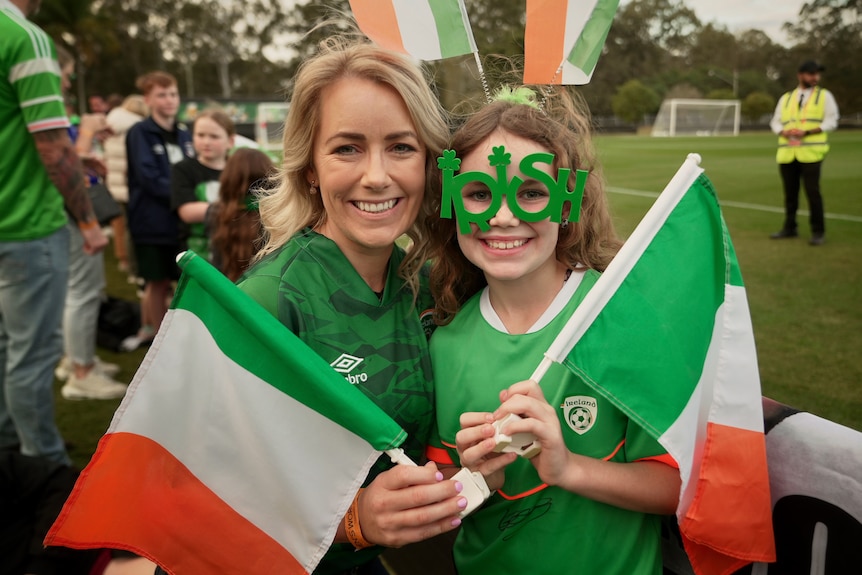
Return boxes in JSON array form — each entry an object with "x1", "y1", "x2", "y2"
[{"x1": 45, "y1": 252, "x2": 412, "y2": 575}]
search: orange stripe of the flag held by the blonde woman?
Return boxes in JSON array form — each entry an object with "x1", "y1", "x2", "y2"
[{"x1": 45, "y1": 433, "x2": 306, "y2": 575}]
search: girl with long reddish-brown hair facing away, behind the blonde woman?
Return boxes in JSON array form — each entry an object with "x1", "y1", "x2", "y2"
[{"x1": 207, "y1": 148, "x2": 273, "y2": 281}]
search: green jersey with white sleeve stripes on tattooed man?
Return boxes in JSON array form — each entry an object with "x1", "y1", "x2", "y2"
[{"x1": 0, "y1": 4, "x2": 69, "y2": 241}]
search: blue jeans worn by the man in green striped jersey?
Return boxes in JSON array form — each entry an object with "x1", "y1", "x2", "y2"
[{"x1": 0, "y1": 227, "x2": 70, "y2": 464}]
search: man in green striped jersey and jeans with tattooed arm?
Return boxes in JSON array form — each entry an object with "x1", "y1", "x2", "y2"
[{"x1": 0, "y1": 0, "x2": 107, "y2": 463}]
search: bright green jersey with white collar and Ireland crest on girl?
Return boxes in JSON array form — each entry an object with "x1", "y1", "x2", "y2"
[{"x1": 436, "y1": 271, "x2": 667, "y2": 575}]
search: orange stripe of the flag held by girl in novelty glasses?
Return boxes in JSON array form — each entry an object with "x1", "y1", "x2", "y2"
[{"x1": 679, "y1": 423, "x2": 775, "y2": 573}]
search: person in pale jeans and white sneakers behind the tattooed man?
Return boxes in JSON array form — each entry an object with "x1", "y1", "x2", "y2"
[{"x1": 57, "y1": 48, "x2": 126, "y2": 399}]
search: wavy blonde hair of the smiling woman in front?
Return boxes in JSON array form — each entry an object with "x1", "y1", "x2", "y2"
[{"x1": 257, "y1": 36, "x2": 449, "y2": 302}]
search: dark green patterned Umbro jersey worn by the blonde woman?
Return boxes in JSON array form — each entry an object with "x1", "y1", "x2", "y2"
[{"x1": 238, "y1": 229, "x2": 434, "y2": 574}]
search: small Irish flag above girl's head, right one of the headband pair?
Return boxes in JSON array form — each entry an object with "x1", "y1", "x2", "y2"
[{"x1": 524, "y1": 0, "x2": 619, "y2": 85}]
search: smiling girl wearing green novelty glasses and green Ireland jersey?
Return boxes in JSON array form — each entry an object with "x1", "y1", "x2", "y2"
[{"x1": 429, "y1": 88, "x2": 680, "y2": 575}]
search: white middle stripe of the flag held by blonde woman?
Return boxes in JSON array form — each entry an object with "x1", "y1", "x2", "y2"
[{"x1": 115, "y1": 309, "x2": 379, "y2": 572}]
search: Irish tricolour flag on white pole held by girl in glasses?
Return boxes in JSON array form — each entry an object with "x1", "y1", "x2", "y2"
[{"x1": 533, "y1": 154, "x2": 775, "y2": 575}]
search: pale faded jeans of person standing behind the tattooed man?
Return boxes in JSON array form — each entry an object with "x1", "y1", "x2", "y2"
[{"x1": 63, "y1": 221, "x2": 105, "y2": 366}]
